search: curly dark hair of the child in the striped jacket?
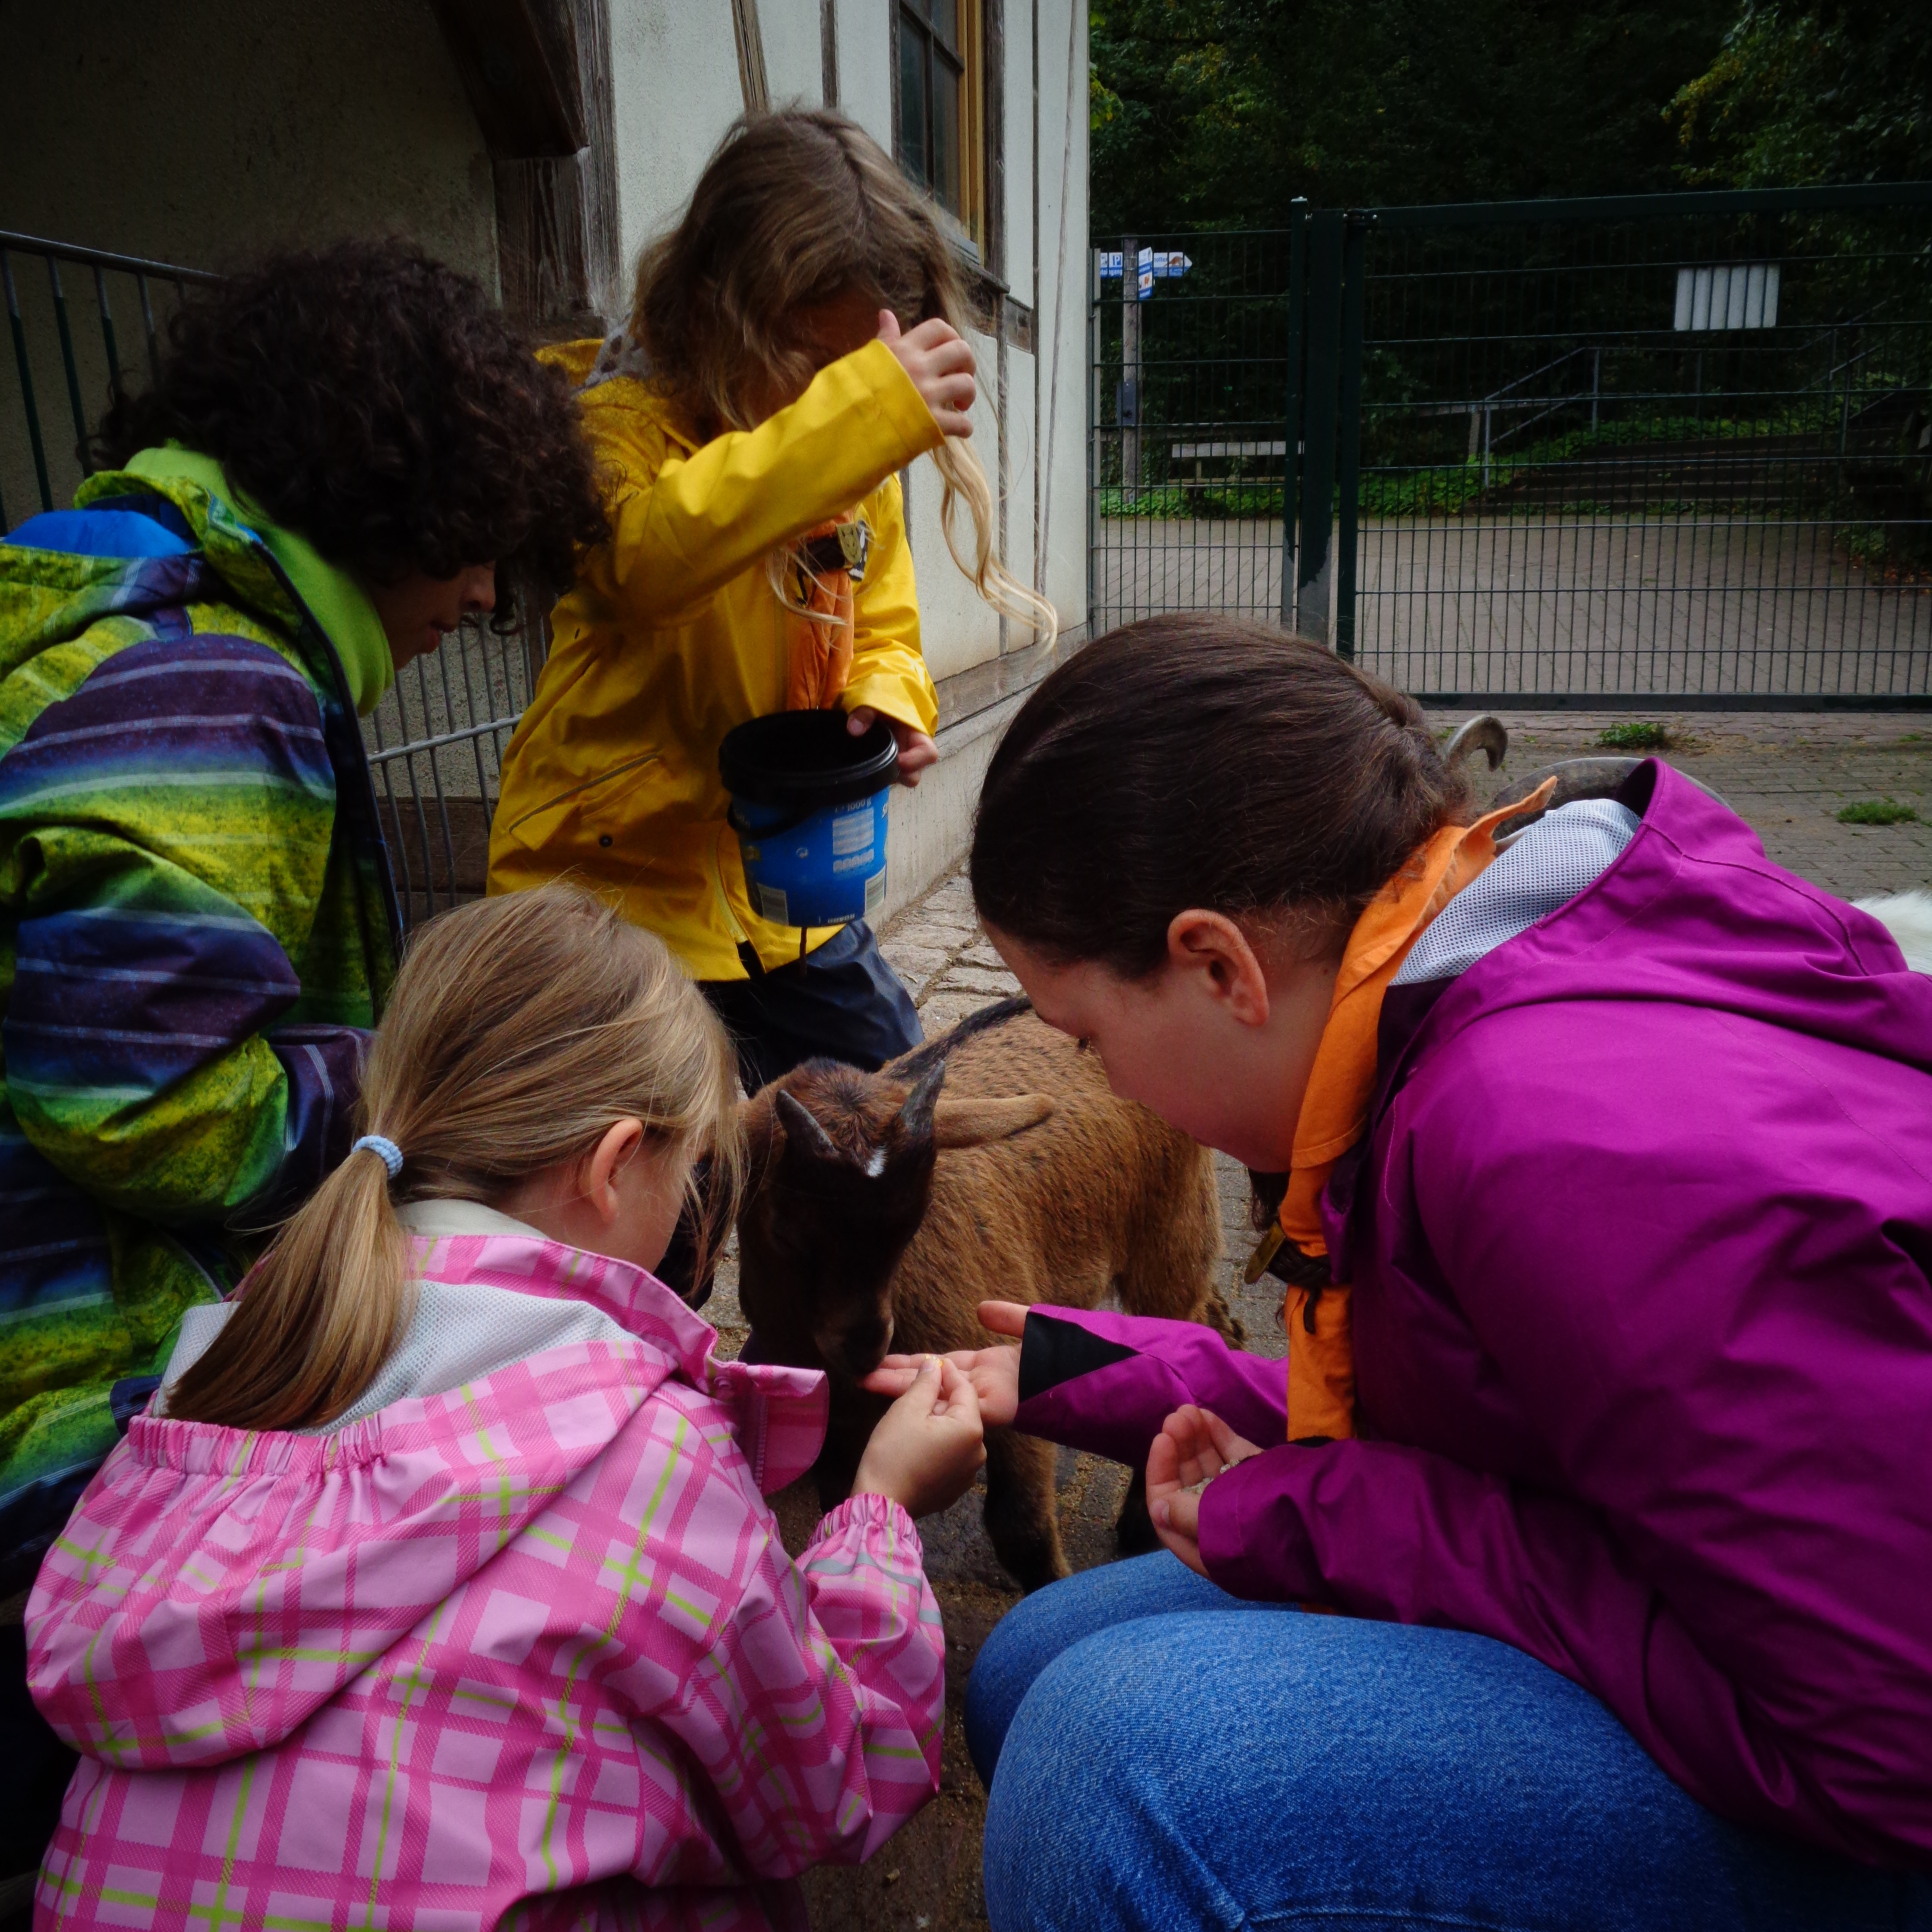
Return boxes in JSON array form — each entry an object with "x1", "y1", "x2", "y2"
[{"x1": 96, "y1": 240, "x2": 606, "y2": 622}]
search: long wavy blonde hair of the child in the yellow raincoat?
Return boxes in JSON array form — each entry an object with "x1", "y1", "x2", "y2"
[{"x1": 630, "y1": 108, "x2": 1058, "y2": 642}]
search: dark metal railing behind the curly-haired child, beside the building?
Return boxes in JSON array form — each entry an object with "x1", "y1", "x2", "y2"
[{"x1": 0, "y1": 232, "x2": 545, "y2": 922}]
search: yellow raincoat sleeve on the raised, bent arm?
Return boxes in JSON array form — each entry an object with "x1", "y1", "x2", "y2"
[{"x1": 597, "y1": 342, "x2": 943, "y2": 624}]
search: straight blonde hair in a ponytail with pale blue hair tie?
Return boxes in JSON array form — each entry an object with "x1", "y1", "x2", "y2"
[{"x1": 168, "y1": 885, "x2": 742, "y2": 1430}]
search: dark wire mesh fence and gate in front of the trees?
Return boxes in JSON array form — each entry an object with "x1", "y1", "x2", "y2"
[{"x1": 1092, "y1": 186, "x2": 1932, "y2": 707}]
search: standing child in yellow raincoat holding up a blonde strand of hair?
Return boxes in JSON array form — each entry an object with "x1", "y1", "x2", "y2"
[{"x1": 489, "y1": 110, "x2": 1053, "y2": 1166}]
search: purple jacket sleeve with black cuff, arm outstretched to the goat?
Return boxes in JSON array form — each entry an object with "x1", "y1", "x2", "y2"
[{"x1": 1014, "y1": 1306, "x2": 1288, "y2": 1468}]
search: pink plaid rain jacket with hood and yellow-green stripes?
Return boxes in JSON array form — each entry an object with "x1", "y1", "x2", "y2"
[{"x1": 27, "y1": 1234, "x2": 944, "y2": 1932}]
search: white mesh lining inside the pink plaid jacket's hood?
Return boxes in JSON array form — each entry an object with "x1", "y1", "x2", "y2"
[{"x1": 156, "y1": 1281, "x2": 632, "y2": 1436}]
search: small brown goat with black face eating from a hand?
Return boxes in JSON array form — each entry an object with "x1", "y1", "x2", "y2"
[{"x1": 738, "y1": 1001, "x2": 1238, "y2": 1590}]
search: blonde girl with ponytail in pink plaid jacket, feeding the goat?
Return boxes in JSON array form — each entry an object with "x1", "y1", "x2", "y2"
[{"x1": 27, "y1": 885, "x2": 984, "y2": 1926}]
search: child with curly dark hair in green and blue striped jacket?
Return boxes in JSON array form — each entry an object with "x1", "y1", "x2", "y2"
[{"x1": 0, "y1": 242, "x2": 604, "y2": 1878}]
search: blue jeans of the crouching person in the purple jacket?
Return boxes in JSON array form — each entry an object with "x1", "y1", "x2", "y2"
[{"x1": 966, "y1": 1552, "x2": 1932, "y2": 1932}]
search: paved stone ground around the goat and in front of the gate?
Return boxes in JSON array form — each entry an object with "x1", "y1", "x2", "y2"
[{"x1": 726, "y1": 713, "x2": 1932, "y2": 1932}]
